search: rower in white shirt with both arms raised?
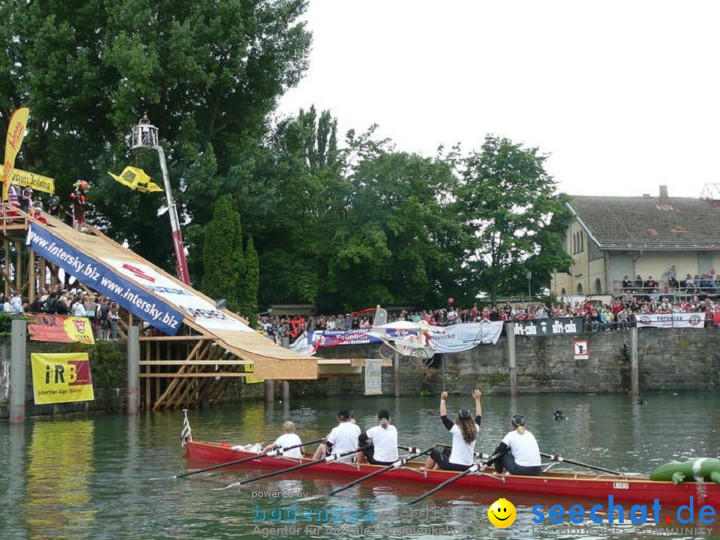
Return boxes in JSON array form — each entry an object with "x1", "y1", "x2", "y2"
[{"x1": 425, "y1": 388, "x2": 482, "y2": 471}]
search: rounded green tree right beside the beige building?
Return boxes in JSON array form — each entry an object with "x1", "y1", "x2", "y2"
[{"x1": 455, "y1": 135, "x2": 567, "y2": 302}]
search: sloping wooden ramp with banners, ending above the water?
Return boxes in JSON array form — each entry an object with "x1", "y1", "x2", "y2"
[{"x1": 26, "y1": 214, "x2": 318, "y2": 410}]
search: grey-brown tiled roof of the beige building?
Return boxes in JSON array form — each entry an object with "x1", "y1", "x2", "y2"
[{"x1": 569, "y1": 196, "x2": 720, "y2": 251}]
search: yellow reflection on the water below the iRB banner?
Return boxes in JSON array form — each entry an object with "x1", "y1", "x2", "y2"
[{"x1": 23, "y1": 420, "x2": 96, "y2": 538}]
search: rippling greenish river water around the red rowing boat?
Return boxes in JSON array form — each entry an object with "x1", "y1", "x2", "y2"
[{"x1": 0, "y1": 393, "x2": 720, "y2": 540}]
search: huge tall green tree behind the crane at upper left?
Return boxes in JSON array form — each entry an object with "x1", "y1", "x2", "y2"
[{"x1": 0, "y1": 0, "x2": 310, "y2": 278}]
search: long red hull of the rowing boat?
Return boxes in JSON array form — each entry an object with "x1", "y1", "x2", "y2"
[{"x1": 185, "y1": 441, "x2": 720, "y2": 508}]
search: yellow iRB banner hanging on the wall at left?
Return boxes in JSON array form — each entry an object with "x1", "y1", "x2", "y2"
[{"x1": 30, "y1": 353, "x2": 95, "y2": 405}]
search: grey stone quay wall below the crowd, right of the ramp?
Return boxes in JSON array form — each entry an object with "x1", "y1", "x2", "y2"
[{"x1": 306, "y1": 328, "x2": 720, "y2": 395}]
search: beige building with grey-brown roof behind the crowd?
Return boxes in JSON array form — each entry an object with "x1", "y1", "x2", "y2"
[{"x1": 551, "y1": 186, "x2": 720, "y2": 297}]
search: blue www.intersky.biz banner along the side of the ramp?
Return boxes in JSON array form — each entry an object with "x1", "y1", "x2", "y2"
[{"x1": 27, "y1": 224, "x2": 183, "y2": 336}]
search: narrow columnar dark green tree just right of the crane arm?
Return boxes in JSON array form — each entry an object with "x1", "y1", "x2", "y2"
[{"x1": 202, "y1": 195, "x2": 245, "y2": 311}]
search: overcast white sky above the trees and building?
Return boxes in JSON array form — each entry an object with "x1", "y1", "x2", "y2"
[{"x1": 280, "y1": 0, "x2": 720, "y2": 197}]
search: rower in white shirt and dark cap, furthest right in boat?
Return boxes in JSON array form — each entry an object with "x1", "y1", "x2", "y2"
[{"x1": 487, "y1": 414, "x2": 541, "y2": 476}]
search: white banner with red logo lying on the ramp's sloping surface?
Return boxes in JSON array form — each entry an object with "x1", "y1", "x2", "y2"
[{"x1": 102, "y1": 257, "x2": 254, "y2": 332}]
